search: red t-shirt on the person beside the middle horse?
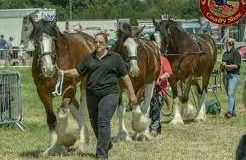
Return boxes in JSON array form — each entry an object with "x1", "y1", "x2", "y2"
[{"x1": 155, "y1": 55, "x2": 172, "y2": 95}]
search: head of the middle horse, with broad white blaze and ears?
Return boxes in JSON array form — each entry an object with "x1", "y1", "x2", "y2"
[{"x1": 118, "y1": 23, "x2": 144, "y2": 77}]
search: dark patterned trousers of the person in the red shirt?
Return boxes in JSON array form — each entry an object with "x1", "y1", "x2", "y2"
[{"x1": 149, "y1": 93, "x2": 164, "y2": 133}]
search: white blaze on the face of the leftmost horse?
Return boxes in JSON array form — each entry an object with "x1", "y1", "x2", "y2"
[{"x1": 40, "y1": 34, "x2": 55, "y2": 77}]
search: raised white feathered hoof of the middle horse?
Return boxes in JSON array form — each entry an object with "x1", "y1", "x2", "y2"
[{"x1": 131, "y1": 106, "x2": 150, "y2": 133}]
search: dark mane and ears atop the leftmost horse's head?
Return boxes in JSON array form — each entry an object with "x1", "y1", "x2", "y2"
[{"x1": 29, "y1": 19, "x2": 64, "y2": 40}]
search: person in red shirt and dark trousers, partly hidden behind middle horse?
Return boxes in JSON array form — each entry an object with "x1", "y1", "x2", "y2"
[{"x1": 150, "y1": 55, "x2": 172, "y2": 136}]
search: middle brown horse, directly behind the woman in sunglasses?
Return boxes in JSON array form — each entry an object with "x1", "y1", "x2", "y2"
[{"x1": 112, "y1": 23, "x2": 160, "y2": 140}]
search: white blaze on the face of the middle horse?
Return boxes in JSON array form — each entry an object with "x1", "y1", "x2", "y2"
[{"x1": 124, "y1": 37, "x2": 139, "y2": 77}]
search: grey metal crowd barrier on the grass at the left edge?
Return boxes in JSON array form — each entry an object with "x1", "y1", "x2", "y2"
[{"x1": 0, "y1": 71, "x2": 24, "y2": 130}]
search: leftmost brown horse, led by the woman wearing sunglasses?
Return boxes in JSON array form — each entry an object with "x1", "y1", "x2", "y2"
[{"x1": 30, "y1": 19, "x2": 94, "y2": 155}]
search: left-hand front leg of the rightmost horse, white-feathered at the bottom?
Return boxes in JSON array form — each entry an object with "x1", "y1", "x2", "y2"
[{"x1": 169, "y1": 78, "x2": 184, "y2": 125}]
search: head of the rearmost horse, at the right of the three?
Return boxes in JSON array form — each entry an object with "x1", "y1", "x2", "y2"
[{"x1": 153, "y1": 17, "x2": 176, "y2": 52}]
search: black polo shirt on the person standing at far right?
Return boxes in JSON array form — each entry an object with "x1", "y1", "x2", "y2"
[{"x1": 222, "y1": 47, "x2": 241, "y2": 74}]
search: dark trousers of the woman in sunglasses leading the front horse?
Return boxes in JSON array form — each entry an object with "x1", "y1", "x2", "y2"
[{"x1": 86, "y1": 92, "x2": 119, "y2": 158}]
